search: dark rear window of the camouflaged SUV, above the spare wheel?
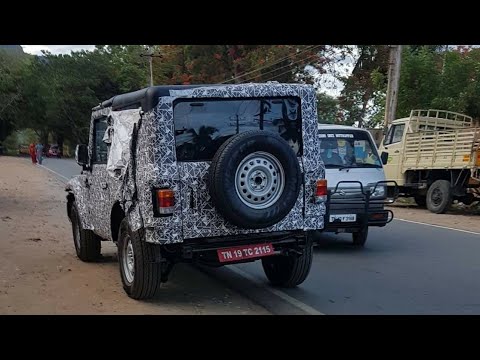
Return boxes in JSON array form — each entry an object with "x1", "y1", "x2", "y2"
[{"x1": 173, "y1": 97, "x2": 302, "y2": 161}]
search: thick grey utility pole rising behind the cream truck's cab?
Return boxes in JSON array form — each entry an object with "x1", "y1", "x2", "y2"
[{"x1": 384, "y1": 45, "x2": 402, "y2": 133}]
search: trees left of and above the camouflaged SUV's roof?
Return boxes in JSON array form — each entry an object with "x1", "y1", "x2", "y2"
[{"x1": 0, "y1": 45, "x2": 342, "y2": 144}]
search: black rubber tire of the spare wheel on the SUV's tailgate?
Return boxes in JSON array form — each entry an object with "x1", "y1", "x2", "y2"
[{"x1": 209, "y1": 130, "x2": 302, "y2": 229}]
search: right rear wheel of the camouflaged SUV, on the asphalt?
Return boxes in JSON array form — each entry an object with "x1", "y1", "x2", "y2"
[{"x1": 262, "y1": 238, "x2": 313, "y2": 288}]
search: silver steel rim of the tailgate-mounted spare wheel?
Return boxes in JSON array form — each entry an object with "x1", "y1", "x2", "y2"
[{"x1": 235, "y1": 151, "x2": 285, "y2": 209}]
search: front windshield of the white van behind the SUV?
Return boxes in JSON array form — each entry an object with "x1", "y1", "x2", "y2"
[{"x1": 319, "y1": 130, "x2": 382, "y2": 168}]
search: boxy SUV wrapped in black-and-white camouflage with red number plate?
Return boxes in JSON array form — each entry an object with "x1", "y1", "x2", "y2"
[{"x1": 66, "y1": 83, "x2": 327, "y2": 299}]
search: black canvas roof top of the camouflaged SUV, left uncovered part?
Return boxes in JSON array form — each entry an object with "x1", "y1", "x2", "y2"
[{"x1": 92, "y1": 84, "x2": 215, "y2": 111}]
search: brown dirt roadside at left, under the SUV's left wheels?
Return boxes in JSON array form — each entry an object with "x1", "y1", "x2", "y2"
[{"x1": 0, "y1": 156, "x2": 269, "y2": 315}]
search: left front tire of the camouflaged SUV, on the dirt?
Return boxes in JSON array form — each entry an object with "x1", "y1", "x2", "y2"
[{"x1": 70, "y1": 202, "x2": 102, "y2": 262}]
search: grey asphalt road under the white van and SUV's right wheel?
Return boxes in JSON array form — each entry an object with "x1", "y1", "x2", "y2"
[{"x1": 40, "y1": 159, "x2": 480, "y2": 314}]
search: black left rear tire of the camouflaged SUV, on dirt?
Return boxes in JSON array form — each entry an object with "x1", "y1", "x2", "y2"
[{"x1": 118, "y1": 218, "x2": 161, "y2": 300}]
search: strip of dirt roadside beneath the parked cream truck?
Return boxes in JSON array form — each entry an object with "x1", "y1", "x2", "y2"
[{"x1": 388, "y1": 199, "x2": 480, "y2": 233}]
